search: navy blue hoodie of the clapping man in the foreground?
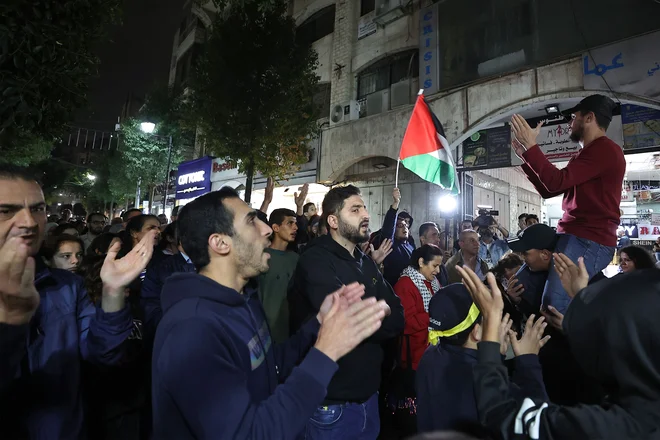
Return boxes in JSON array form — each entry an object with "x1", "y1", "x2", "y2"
[{"x1": 152, "y1": 273, "x2": 337, "y2": 440}]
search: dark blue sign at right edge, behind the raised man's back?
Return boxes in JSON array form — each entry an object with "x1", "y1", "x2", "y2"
[{"x1": 621, "y1": 104, "x2": 660, "y2": 150}]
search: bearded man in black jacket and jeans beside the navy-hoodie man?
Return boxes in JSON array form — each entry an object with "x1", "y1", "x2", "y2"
[{"x1": 289, "y1": 185, "x2": 404, "y2": 440}]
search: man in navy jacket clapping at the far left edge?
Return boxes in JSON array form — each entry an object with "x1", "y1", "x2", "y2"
[{"x1": 0, "y1": 166, "x2": 154, "y2": 439}]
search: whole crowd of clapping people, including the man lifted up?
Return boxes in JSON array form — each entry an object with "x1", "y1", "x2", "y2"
[{"x1": 0, "y1": 95, "x2": 660, "y2": 440}]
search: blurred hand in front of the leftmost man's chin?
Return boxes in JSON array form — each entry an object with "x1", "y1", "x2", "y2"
[{"x1": 0, "y1": 237, "x2": 39, "y2": 325}]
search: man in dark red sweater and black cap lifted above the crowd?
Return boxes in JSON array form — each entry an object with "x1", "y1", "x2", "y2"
[{"x1": 511, "y1": 95, "x2": 626, "y2": 313}]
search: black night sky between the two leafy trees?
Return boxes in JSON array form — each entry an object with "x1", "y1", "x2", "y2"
[{"x1": 75, "y1": 0, "x2": 184, "y2": 130}]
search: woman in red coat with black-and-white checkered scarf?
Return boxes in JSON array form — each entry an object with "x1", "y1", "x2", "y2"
[{"x1": 394, "y1": 244, "x2": 442, "y2": 370}]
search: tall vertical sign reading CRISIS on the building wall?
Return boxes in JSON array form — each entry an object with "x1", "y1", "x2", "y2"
[{"x1": 419, "y1": 3, "x2": 440, "y2": 95}]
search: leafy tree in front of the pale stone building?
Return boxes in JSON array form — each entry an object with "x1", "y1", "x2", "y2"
[{"x1": 188, "y1": 0, "x2": 319, "y2": 202}]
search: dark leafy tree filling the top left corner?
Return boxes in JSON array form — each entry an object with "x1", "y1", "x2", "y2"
[{"x1": 0, "y1": 0, "x2": 121, "y2": 164}]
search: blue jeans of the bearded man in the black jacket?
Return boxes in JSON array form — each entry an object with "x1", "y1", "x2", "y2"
[{"x1": 305, "y1": 393, "x2": 380, "y2": 440}]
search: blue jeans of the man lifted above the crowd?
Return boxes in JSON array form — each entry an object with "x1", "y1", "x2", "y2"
[{"x1": 516, "y1": 234, "x2": 616, "y2": 314}]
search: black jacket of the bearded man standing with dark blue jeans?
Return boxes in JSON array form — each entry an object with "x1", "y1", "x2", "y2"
[{"x1": 289, "y1": 235, "x2": 404, "y2": 404}]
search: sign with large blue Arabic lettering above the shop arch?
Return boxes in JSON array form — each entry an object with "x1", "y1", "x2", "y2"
[{"x1": 582, "y1": 31, "x2": 660, "y2": 97}]
